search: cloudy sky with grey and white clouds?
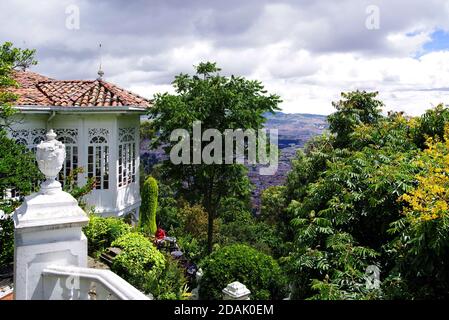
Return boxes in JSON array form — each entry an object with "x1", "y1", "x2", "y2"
[{"x1": 0, "y1": 0, "x2": 449, "y2": 115}]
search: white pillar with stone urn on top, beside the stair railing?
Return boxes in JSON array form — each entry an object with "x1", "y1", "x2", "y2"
[{"x1": 14, "y1": 130, "x2": 89, "y2": 300}]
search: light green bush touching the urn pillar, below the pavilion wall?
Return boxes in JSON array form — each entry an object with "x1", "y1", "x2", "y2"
[{"x1": 83, "y1": 214, "x2": 132, "y2": 254}]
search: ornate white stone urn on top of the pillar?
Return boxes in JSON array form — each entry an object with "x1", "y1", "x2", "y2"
[{"x1": 36, "y1": 129, "x2": 66, "y2": 194}]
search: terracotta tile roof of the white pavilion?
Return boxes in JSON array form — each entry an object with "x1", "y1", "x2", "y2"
[{"x1": 10, "y1": 71, "x2": 151, "y2": 107}]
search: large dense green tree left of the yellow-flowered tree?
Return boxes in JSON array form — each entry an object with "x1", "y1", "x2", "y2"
[{"x1": 280, "y1": 92, "x2": 430, "y2": 299}]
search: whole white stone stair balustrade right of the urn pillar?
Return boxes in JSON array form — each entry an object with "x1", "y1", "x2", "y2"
[{"x1": 42, "y1": 266, "x2": 152, "y2": 300}]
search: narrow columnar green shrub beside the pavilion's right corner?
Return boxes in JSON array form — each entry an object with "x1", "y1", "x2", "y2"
[{"x1": 139, "y1": 176, "x2": 159, "y2": 235}]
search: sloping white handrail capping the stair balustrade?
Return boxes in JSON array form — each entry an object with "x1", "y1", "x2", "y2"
[{"x1": 42, "y1": 266, "x2": 151, "y2": 300}]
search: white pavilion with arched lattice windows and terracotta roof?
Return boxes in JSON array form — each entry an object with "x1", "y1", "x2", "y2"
[{"x1": 9, "y1": 71, "x2": 150, "y2": 217}]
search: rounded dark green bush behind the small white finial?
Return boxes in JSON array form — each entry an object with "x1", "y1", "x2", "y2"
[{"x1": 200, "y1": 244, "x2": 285, "y2": 299}]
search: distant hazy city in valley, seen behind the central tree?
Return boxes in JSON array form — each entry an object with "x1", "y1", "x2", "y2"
[{"x1": 140, "y1": 112, "x2": 328, "y2": 213}]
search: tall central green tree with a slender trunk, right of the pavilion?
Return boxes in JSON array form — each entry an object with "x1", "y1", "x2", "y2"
[{"x1": 149, "y1": 62, "x2": 280, "y2": 252}]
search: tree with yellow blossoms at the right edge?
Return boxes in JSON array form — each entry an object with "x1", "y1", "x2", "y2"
[{"x1": 387, "y1": 124, "x2": 449, "y2": 299}]
